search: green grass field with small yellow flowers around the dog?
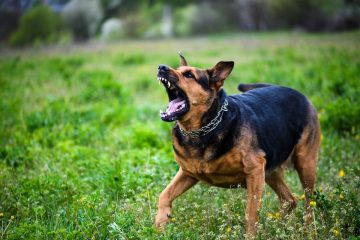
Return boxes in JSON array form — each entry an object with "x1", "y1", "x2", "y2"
[{"x1": 0, "y1": 32, "x2": 360, "y2": 239}]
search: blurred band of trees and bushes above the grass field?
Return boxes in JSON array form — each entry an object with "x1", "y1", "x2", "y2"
[{"x1": 0, "y1": 0, "x2": 360, "y2": 47}]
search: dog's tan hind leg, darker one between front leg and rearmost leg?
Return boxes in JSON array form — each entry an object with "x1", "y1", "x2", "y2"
[{"x1": 265, "y1": 167, "x2": 297, "y2": 212}]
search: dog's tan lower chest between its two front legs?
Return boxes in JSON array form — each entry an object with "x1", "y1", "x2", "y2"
[{"x1": 175, "y1": 145, "x2": 245, "y2": 187}]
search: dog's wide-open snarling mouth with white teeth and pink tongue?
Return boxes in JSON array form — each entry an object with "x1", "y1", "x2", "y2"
[{"x1": 157, "y1": 76, "x2": 189, "y2": 122}]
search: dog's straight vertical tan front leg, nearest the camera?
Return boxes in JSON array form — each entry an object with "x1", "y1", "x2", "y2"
[{"x1": 246, "y1": 161, "x2": 265, "y2": 238}]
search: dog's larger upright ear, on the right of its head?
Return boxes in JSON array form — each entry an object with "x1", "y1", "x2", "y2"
[{"x1": 207, "y1": 61, "x2": 234, "y2": 91}]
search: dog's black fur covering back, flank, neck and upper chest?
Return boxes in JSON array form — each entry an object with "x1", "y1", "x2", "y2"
[{"x1": 174, "y1": 86, "x2": 310, "y2": 170}]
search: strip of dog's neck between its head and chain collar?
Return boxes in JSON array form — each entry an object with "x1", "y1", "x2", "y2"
[{"x1": 177, "y1": 89, "x2": 226, "y2": 131}]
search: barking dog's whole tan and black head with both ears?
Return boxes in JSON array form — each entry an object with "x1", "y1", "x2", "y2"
[{"x1": 157, "y1": 53, "x2": 234, "y2": 122}]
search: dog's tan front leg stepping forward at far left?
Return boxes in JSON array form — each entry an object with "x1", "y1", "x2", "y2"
[{"x1": 155, "y1": 168, "x2": 198, "y2": 228}]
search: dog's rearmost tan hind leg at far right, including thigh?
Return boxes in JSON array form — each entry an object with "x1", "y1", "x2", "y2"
[{"x1": 293, "y1": 108, "x2": 321, "y2": 223}]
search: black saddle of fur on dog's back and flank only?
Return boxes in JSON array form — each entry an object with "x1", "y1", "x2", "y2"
[{"x1": 231, "y1": 84, "x2": 311, "y2": 170}]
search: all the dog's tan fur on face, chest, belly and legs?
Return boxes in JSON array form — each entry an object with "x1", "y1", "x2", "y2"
[{"x1": 155, "y1": 59, "x2": 320, "y2": 236}]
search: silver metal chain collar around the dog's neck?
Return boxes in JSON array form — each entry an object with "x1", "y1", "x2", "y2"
[{"x1": 179, "y1": 99, "x2": 228, "y2": 138}]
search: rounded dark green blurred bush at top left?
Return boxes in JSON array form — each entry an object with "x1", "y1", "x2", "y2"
[{"x1": 10, "y1": 5, "x2": 62, "y2": 46}]
